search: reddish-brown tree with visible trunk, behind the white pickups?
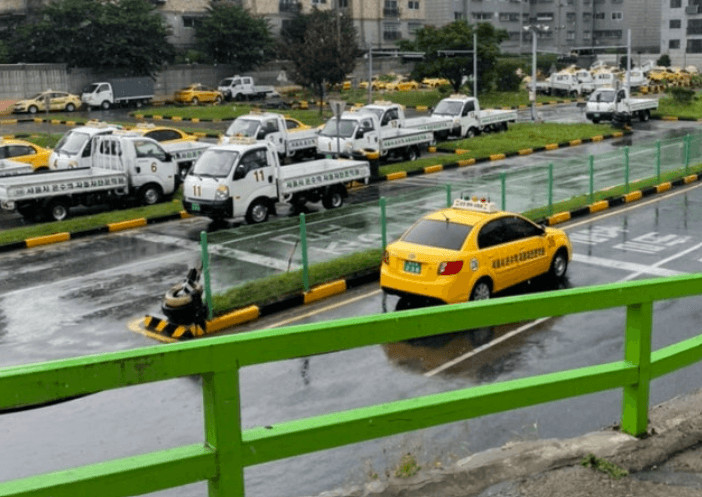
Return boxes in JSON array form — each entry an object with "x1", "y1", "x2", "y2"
[{"x1": 279, "y1": 8, "x2": 360, "y2": 112}]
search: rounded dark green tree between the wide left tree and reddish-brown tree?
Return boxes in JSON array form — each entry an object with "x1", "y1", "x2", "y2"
[{"x1": 195, "y1": 3, "x2": 274, "y2": 72}]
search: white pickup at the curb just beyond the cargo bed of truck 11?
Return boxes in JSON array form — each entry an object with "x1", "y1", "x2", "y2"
[{"x1": 317, "y1": 111, "x2": 435, "y2": 162}]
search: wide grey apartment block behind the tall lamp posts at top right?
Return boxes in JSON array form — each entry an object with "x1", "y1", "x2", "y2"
[{"x1": 427, "y1": 0, "x2": 664, "y2": 54}]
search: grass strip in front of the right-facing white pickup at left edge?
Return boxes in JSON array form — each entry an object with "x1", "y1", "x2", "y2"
[{"x1": 0, "y1": 199, "x2": 183, "y2": 245}]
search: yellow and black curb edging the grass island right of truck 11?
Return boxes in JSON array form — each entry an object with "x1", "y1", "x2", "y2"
[{"x1": 380, "y1": 130, "x2": 631, "y2": 183}]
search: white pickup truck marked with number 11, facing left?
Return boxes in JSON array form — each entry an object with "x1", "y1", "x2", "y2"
[{"x1": 183, "y1": 138, "x2": 370, "y2": 224}]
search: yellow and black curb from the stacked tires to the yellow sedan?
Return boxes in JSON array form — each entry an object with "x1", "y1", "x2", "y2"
[{"x1": 143, "y1": 269, "x2": 380, "y2": 342}]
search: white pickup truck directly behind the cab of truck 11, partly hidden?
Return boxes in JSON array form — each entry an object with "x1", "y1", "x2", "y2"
[{"x1": 219, "y1": 112, "x2": 317, "y2": 161}]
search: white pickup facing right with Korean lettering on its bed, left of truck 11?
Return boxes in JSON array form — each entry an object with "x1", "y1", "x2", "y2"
[{"x1": 0, "y1": 135, "x2": 178, "y2": 221}]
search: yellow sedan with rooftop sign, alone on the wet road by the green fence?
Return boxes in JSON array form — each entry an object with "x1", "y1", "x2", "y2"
[{"x1": 380, "y1": 198, "x2": 573, "y2": 304}]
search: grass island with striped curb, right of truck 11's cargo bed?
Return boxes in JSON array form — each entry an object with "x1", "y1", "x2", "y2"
[{"x1": 380, "y1": 123, "x2": 617, "y2": 176}]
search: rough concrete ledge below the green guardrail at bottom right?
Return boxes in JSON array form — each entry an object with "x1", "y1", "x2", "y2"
[{"x1": 332, "y1": 391, "x2": 702, "y2": 497}]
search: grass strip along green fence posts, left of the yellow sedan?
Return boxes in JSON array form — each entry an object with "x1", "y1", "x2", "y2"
[{"x1": 212, "y1": 248, "x2": 382, "y2": 315}]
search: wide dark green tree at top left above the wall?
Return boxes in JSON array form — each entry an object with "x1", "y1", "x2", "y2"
[{"x1": 7, "y1": 0, "x2": 174, "y2": 75}]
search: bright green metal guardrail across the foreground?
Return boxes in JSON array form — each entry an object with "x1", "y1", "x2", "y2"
[{"x1": 0, "y1": 275, "x2": 702, "y2": 497}]
